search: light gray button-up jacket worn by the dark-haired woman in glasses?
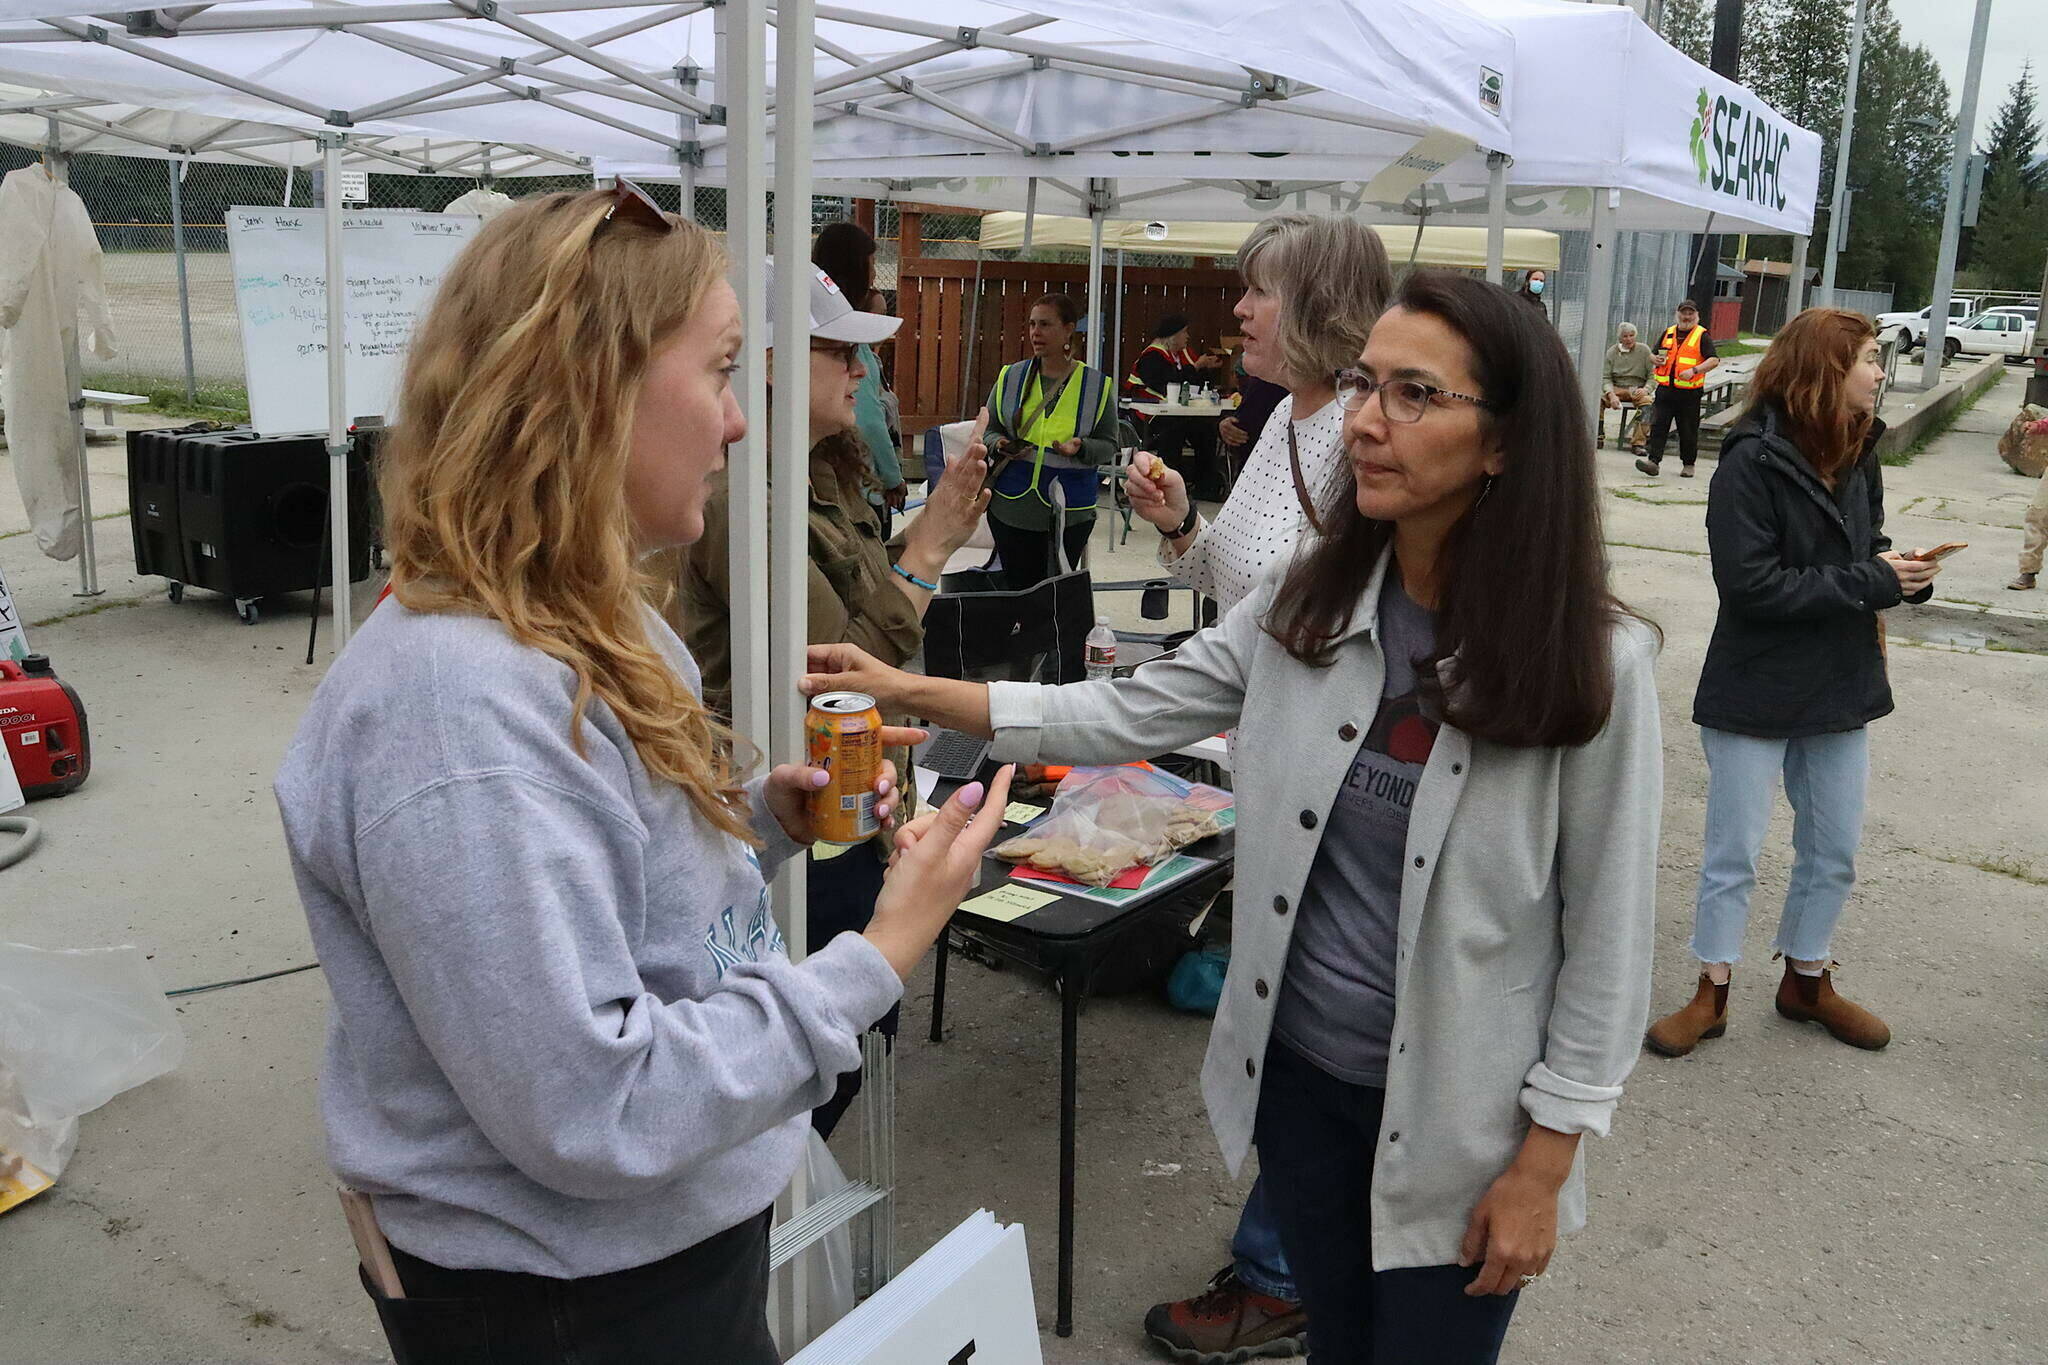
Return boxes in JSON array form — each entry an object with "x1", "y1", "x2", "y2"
[{"x1": 989, "y1": 557, "x2": 1663, "y2": 1271}]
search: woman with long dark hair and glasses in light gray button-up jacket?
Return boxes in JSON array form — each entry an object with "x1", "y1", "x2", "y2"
[{"x1": 805, "y1": 270, "x2": 1663, "y2": 1365}]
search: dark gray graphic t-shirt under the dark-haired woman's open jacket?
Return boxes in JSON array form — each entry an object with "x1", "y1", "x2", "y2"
[{"x1": 1274, "y1": 571, "x2": 1442, "y2": 1087}]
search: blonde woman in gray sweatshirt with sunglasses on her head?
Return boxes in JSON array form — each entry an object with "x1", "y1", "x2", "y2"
[{"x1": 276, "y1": 182, "x2": 1008, "y2": 1365}]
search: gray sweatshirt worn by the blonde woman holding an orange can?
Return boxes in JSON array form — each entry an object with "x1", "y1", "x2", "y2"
[{"x1": 276, "y1": 600, "x2": 901, "y2": 1277}]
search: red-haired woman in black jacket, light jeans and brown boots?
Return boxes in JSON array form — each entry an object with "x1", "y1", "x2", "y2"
[{"x1": 1647, "y1": 309, "x2": 1942, "y2": 1056}]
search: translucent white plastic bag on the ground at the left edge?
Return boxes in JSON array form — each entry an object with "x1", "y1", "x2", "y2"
[{"x1": 0, "y1": 943, "x2": 184, "y2": 1179}]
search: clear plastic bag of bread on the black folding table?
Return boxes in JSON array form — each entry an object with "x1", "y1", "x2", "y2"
[{"x1": 995, "y1": 767, "x2": 1229, "y2": 886}]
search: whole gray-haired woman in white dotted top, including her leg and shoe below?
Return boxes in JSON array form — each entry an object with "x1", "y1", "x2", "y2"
[{"x1": 1124, "y1": 213, "x2": 1393, "y2": 1361}]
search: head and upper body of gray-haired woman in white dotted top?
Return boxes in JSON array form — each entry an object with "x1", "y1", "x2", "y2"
[{"x1": 1124, "y1": 213, "x2": 1393, "y2": 612}]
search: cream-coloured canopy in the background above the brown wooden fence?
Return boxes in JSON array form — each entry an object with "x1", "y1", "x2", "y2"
[{"x1": 981, "y1": 213, "x2": 1559, "y2": 270}]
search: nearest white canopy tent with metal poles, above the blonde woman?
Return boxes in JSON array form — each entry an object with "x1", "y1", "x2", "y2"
[{"x1": 0, "y1": 0, "x2": 1513, "y2": 1345}]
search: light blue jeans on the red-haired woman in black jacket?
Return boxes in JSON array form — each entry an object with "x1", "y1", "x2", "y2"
[{"x1": 1692, "y1": 726, "x2": 1870, "y2": 962}]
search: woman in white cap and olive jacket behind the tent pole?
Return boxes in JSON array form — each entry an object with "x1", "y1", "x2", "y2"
[{"x1": 678, "y1": 262, "x2": 989, "y2": 1136}]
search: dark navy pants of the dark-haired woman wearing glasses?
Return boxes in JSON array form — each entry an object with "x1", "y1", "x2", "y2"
[{"x1": 1255, "y1": 1042, "x2": 1520, "y2": 1365}]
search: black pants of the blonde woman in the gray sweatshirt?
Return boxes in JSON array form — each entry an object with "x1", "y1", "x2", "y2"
[{"x1": 362, "y1": 1209, "x2": 782, "y2": 1365}]
